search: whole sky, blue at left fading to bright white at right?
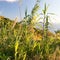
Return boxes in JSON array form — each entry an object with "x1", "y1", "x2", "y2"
[{"x1": 0, "y1": 0, "x2": 60, "y2": 29}]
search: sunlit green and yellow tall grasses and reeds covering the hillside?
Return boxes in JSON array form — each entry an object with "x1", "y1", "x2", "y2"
[{"x1": 0, "y1": 0, "x2": 60, "y2": 60}]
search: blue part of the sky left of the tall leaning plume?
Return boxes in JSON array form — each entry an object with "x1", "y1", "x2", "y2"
[{"x1": 0, "y1": 0, "x2": 36, "y2": 19}]
